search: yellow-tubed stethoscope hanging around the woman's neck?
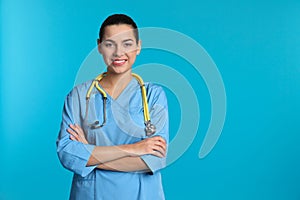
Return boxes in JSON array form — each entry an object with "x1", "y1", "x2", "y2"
[{"x1": 86, "y1": 72, "x2": 156, "y2": 136}]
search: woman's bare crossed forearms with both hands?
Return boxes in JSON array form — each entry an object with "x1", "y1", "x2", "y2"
[{"x1": 67, "y1": 124, "x2": 167, "y2": 172}]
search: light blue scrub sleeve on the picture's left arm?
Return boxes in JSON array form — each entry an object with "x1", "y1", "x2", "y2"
[{"x1": 56, "y1": 92, "x2": 96, "y2": 177}]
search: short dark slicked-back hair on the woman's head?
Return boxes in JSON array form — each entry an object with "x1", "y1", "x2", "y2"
[{"x1": 99, "y1": 14, "x2": 139, "y2": 43}]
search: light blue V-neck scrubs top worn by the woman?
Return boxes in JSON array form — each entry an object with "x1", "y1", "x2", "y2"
[{"x1": 56, "y1": 78, "x2": 169, "y2": 200}]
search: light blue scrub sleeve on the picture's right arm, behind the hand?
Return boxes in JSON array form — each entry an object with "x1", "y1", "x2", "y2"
[{"x1": 141, "y1": 86, "x2": 169, "y2": 174}]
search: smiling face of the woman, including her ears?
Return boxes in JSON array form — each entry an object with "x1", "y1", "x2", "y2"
[{"x1": 98, "y1": 24, "x2": 141, "y2": 74}]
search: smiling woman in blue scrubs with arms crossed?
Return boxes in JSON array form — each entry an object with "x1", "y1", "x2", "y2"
[{"x1": 57, "y1": 14, "x2": 169, "y2": 200}]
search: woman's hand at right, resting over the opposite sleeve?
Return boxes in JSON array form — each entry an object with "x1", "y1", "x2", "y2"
[{"x1": 128, "y1": 136, "x2": 167, "y2": 158}]
